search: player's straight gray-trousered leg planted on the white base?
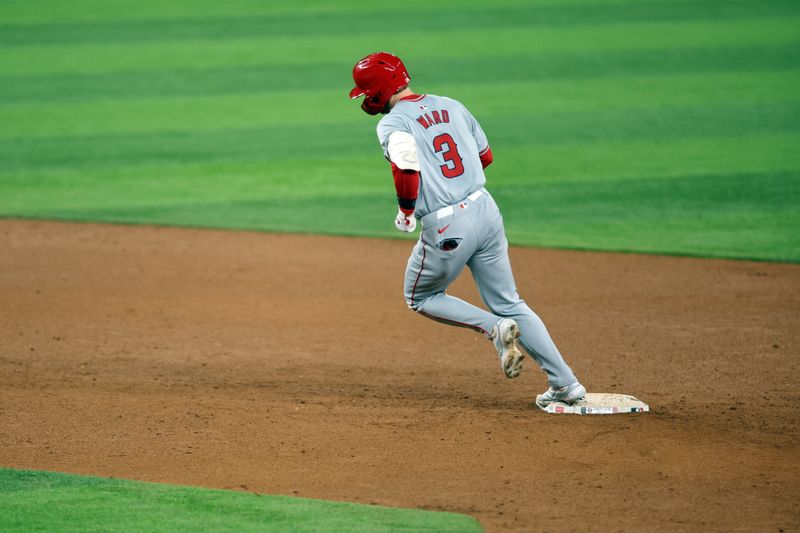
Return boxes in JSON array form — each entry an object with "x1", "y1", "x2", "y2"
[{"x1": 468, "y1": 200, "x2": 577, "y2": 388}]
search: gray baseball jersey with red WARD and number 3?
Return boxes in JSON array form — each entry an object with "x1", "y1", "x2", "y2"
[{"x1": 378, "y1": 94, "x2": 489, "y2": 218}]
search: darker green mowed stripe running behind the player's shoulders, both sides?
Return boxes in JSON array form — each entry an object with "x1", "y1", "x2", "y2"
[{"x1": 0, "y1": 103, "x2": 800, "y2": 171}]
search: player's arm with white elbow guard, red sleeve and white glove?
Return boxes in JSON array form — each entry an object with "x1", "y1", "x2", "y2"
[{"x1": 386, "y1": 131, "x2": 419, "y2": 231}]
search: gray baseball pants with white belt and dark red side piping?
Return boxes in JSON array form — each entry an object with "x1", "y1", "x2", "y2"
[{"x1": 404, "y1": 188, "x2": 577, "y2": 388}]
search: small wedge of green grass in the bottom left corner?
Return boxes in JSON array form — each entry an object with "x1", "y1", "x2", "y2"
[{"x1": 0, "y1": 468, "x2": 481, "y2": 532}]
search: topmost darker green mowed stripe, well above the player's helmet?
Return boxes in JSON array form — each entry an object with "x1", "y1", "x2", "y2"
[{"x1": 0, "y1": 0, "x2": 800, "y2": 46}]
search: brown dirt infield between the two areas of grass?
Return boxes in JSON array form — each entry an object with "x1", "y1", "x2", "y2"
[{"x1": 0, "y1": 220, "x2": 800, "y2": 531}]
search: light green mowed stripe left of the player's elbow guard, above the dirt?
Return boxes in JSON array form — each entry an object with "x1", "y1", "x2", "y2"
[{"x1": 0, "y1": 153, "x2": 396, "y2": 213}]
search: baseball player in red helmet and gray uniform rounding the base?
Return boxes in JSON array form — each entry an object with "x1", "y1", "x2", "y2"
[{"x1": 350, "y1": 52, "x2": 586, "y2": 408}]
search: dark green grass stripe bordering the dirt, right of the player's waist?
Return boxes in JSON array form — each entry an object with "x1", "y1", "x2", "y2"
[{"x1": 494, "y1": 171, "x2": 800, "y2": 261}]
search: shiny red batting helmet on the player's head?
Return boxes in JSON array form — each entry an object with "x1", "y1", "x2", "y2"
[{"x1": 350, "y1": 52, "x2": 411, "y2": 115}]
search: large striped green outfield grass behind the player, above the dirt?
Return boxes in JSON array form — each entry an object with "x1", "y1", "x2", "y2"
[{"x1": 0, "y1": 0, "x2": 800, "y2": 262}]
